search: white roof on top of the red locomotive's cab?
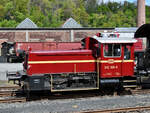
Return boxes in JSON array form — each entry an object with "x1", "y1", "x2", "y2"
[{"x1": 91, "y1": 35, "x2": 137, "y2": 43}]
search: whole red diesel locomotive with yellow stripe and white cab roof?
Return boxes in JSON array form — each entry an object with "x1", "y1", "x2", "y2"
[{"x1": 8, "y1": 34, "x2": 136, "y2": 92}]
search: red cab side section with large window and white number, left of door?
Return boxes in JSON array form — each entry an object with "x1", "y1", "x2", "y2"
[{"x1": 99, "y1": 43, "x2": 122, "y2": 78}]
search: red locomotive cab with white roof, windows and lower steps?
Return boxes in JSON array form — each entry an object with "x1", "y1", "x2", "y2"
[{"x1": 83, "y1": 34, "x2": 136, "y2": 87}]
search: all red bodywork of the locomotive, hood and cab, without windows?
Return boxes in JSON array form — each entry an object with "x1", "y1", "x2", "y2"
[{"x1": 24, "y1": 34, "x2": 134, "y2": 78}]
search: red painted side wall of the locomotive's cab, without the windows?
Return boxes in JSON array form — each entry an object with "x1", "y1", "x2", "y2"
[{"x1": 99, "y1": 44, "x2": 134, "y2": 78}]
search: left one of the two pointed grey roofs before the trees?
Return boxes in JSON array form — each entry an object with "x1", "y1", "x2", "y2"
[{"x1": 16, "y1": 18, "x2": 38, "y2": 28}]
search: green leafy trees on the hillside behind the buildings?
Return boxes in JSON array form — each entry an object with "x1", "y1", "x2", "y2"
[{"x1": 0, "y1": 0, "x2": 150, "y2": 27}]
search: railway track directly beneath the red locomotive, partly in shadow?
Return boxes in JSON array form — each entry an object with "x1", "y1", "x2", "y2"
[{"x1": 0, "y1": 86, "x2": 150, "y2": 103}]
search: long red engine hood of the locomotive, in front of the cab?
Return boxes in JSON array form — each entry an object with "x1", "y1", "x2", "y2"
[{"x1": 27, "y1": 50, "x2": 96, "y2": 75}]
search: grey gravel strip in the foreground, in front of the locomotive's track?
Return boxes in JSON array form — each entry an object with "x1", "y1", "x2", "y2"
[{"x1": 0, "y1": 94, "x2": 150, "y2": 113}]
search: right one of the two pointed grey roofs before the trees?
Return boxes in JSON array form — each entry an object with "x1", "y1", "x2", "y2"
[{"x1": 62, "y1": 18, "x2": 82, "y2": 28}]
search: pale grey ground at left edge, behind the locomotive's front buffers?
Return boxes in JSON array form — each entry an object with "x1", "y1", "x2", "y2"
[{"x1": 0, "y1": 63, "x2": 23, "y2": 80}]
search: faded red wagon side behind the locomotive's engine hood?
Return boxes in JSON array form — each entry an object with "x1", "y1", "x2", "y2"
[{"x1": 15, "y1": 42, "x2": 82, "y2": 56}]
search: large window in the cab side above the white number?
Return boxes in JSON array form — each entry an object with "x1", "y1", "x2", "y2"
[{"x1": 104, "y1": 44, "x2": 121, "y2": 57}]
